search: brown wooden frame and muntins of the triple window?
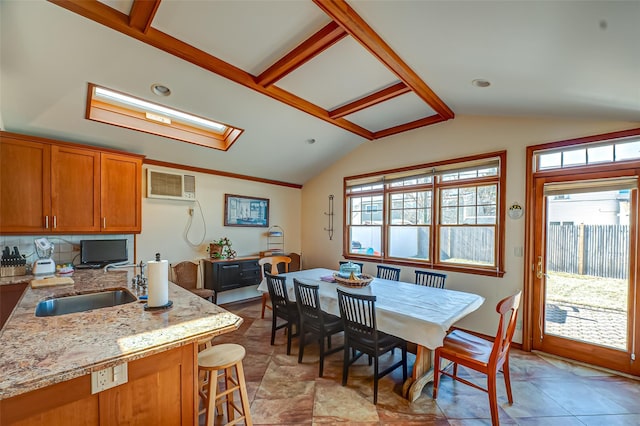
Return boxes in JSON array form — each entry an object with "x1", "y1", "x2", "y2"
[{"x1": 342, "y1": 150, "x2": 507, "y2": 277}]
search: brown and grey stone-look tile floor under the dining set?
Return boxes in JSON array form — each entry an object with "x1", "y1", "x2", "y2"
[{"x1": 201, "y1": 300, "x2": 640, "y2": 426}]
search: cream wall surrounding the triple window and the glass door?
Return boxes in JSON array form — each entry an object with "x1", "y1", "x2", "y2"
[{"x1": 302, "y1": 116, "x2": 639, "y2": 342}]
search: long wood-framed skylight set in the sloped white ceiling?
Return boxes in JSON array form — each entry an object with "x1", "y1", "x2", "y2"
[{"x1": 86, "y1": 83, "x2": 242, "y2": 151}]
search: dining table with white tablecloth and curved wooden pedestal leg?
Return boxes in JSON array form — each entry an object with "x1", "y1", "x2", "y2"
[{"x1": 258, "y1": 268, "x2": 484, "y2": 401}]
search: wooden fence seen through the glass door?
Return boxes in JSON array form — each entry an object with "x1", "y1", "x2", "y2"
[{"x1": 547, "y1": 225, "x2": 629, "y2": 279}]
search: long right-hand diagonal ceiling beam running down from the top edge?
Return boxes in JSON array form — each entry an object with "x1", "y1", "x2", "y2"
[{"x1": 313, "y1": 0, "x2": 455, "y2": 120}]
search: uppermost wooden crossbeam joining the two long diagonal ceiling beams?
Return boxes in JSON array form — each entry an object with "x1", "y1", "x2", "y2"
[{"x1": 256, "y1": 21, "x2": 347, "y2": 87}]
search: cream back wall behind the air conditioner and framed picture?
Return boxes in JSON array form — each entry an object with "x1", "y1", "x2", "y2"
[{"x1": 136, "y1": 166, "x2": 302, "y2": 303}]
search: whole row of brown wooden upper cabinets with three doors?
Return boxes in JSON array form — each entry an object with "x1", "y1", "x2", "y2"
[{"x1": 0, "y1": 132, "x2": 142, "y2": 234}]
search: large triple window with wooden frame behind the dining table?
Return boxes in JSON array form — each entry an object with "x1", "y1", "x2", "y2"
[{"x1": 344, "y1": 151, "x2": 506, "y2": 276}]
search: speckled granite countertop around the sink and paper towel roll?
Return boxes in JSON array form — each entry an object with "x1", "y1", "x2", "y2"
[{"x1": 0, "y1": 270, "x2": 242, "y2": 400}]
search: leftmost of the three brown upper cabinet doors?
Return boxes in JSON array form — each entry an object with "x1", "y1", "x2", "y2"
[{"x1": 0, "y1": 136, "x2": 51, "y2": 234}]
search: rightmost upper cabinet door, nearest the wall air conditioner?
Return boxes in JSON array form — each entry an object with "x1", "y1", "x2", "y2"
[{"x1": 100, "y1": 153, "x2": 142, "y2": 233}]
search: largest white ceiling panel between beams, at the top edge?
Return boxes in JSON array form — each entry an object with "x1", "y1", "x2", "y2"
[{"x1": 152, "y1": 0, "x2": 331, "y2": 75}]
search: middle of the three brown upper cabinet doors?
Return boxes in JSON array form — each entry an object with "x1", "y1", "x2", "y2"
[{"x1": 50, "y1": 145, "x2": 100, "y2": 232}]
